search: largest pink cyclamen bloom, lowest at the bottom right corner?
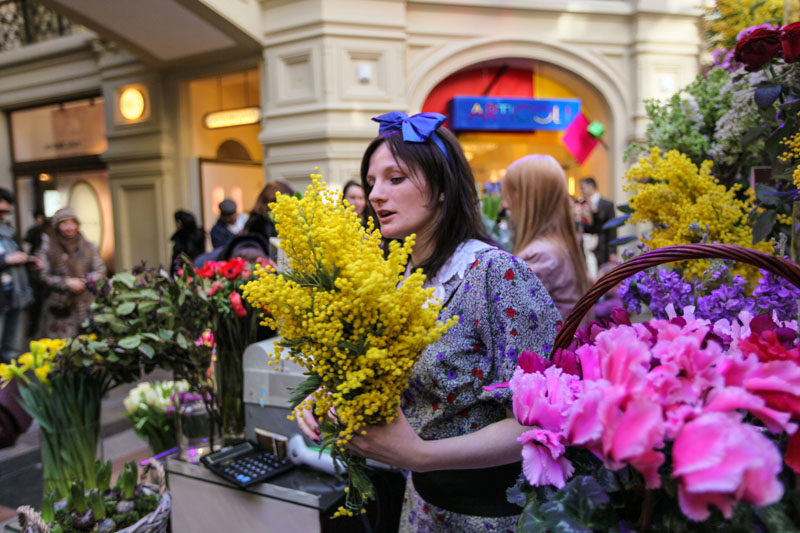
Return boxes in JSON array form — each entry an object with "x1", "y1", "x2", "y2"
[{"x1": 672, "y1": 413, "x2": 783, "y2": 520}]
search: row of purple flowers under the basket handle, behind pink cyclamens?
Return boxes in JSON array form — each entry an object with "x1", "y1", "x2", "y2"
[{"x1": 617, "y1": 263, "x2": 800, "y2": 322}]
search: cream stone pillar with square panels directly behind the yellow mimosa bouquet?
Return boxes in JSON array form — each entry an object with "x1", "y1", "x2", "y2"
[{"x1": 259, "y1": 0, "x2": 407, "y2": 188}]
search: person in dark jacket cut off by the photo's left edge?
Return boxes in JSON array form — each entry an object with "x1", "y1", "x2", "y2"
[{"x1": 0, "y1": 188, "x2": 38, "y2": 363}]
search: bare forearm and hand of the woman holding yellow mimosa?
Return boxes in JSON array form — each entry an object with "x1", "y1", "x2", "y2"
[{"x1": 348, "y1": 411, "x2": 530, "y2": 472}]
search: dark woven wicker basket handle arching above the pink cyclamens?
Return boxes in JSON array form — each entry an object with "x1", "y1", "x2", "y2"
[{"x1": 553, "y1": 243, "x2": 800, "y2": 350}]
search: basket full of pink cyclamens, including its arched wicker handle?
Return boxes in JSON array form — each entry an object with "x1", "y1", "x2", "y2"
[{"x1": 498, "y1": 245, "x2": 800, "y2": 531}]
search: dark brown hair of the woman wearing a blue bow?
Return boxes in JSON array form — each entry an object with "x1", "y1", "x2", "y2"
[{"x1": 361, "y1": 128, "x2": 495, "y2": 276}]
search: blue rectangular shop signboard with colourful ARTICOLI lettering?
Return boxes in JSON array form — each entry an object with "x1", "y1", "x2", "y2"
[{"x1": 450, "y1": 96, "x2": 581, "y2": 131}]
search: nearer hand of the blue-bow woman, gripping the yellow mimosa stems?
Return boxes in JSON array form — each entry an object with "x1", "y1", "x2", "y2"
[{"x1": 347, "y1": 409, "x2": 427, "y2": 472}]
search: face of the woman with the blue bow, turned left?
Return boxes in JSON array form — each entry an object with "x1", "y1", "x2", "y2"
[{"x1": 367, "y1": 143, "x2": 439, "y2": 241}]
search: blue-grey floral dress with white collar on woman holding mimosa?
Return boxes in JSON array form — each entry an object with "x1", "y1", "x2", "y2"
[{"x1": 400, "y1": 240, "x2": 561, "y2": 532}]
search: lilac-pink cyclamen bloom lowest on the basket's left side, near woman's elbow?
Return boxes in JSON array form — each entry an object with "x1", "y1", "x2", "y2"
[{"x1": 517, "y1": 429, "x2": 575, "y2": 489}]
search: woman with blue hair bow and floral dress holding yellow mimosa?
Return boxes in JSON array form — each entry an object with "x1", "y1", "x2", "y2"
[{"x1": 298, "y1": 112, "x2": 560, "y2": 532}]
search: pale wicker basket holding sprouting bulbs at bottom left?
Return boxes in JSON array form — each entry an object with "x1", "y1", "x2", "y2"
[{"x1": 17, "y1": 459, "x2": 172, "y2": 533}]
